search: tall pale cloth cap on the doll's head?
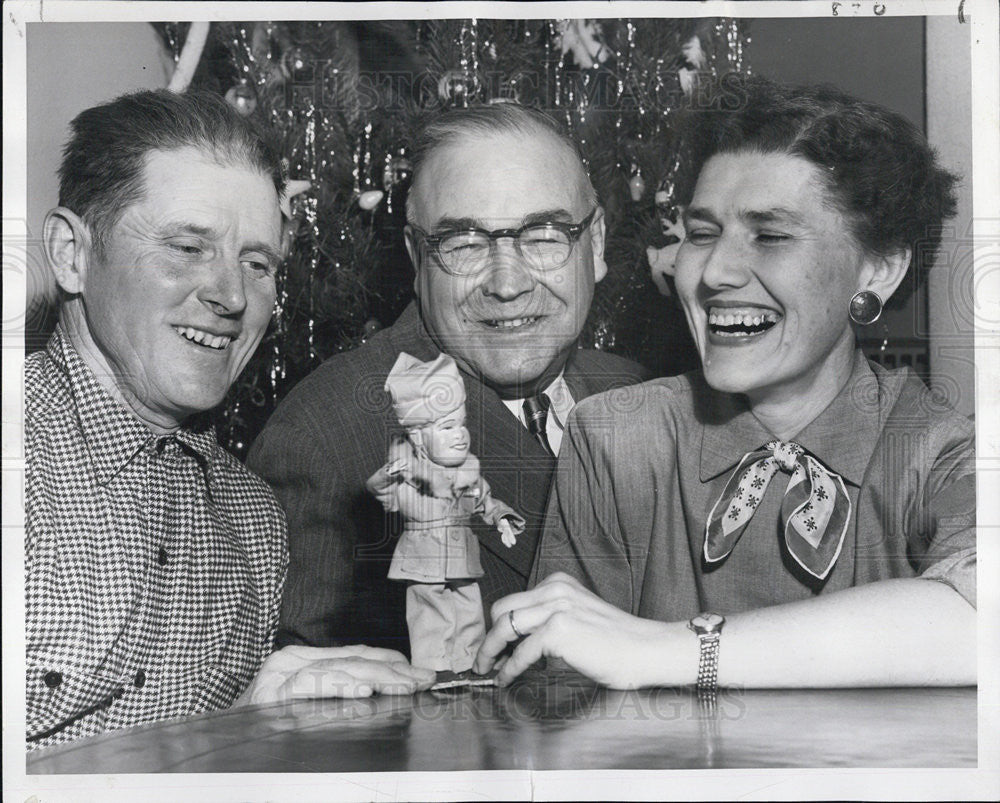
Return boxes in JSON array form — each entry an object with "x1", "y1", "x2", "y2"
[{"x1": 385, "y1": 351, "x2": 465, "y2": 427}]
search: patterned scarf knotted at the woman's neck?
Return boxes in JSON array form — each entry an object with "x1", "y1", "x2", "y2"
[{"x1": 705, "y1": 441, "x2": 851, "y2": 579}]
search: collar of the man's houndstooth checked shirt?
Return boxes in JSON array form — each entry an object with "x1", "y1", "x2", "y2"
[{"x1": 46, "y1": 324, "x2": 216, "y2": 485}]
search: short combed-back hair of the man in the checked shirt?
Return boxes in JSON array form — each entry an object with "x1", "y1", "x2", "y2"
[{"x1": 59, "y1": 89, "x2": 285, "y2": 252}]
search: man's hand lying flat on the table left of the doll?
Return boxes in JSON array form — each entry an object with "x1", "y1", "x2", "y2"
[{"x1": 234, "y1": 644, "x2": 435, "y2": 707}]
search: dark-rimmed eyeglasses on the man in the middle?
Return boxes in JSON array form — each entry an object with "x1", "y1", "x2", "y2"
[{"x1": 410, "y1": 207, "x2": 597, "y2": 276}]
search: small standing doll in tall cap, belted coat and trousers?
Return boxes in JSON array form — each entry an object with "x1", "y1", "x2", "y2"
[{"x1": 368, "y1": 352, "x2": 524, "y2": 679}]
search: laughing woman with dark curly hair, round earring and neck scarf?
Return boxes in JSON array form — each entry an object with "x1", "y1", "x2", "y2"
[{"x1": 476, "y1": 79, "x2": 976, "y2": 689}]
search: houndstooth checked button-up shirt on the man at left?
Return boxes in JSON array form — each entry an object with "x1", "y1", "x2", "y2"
[{"x1": 25, "y1": 329, "x2": 287, "y2": 748}]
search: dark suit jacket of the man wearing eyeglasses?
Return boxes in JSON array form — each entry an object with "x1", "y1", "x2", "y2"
[{"x1": 247, "y1": 304, "x2": 646, "y2": 652}]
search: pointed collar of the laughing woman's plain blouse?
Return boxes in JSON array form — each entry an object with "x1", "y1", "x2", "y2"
[{"x1": 699, "y1": 349, "x2": 882, "y2": 485}]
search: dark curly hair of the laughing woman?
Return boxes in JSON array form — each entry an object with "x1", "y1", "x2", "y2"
[{"x1": 679, "y1": 74, "x2": 958, "y2": 276}]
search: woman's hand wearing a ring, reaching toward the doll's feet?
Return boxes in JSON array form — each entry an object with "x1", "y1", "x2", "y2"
[{"x1": 475, "y1": 573, "x2": 680, "y2": 689}]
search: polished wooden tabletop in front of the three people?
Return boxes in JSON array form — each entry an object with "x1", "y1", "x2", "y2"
[{"x1": 27, "y1": 673, "x2": 977, "y2": 775}]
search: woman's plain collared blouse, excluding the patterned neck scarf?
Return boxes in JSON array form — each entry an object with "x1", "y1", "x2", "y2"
[{"x1": 533, "y1": 351, "x2": 976, "y2": 621}]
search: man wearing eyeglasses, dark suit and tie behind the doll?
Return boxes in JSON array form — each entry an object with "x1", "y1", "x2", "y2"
[{"x1": 248, "y1": 103, "x2": 645, "y2": 650}]
